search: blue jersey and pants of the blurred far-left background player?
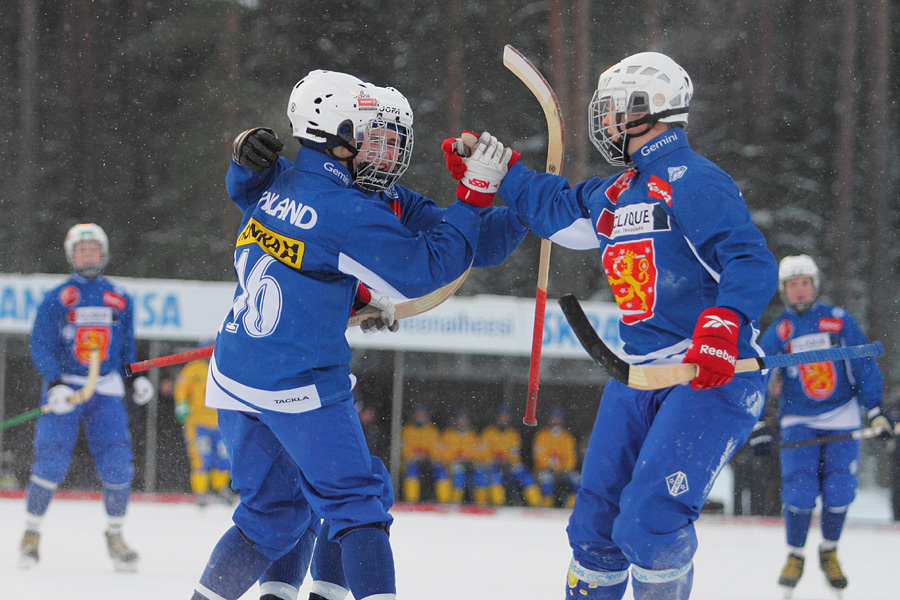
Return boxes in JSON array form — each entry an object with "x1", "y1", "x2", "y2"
[{"x1": 31, "y1": 274, "x2": 136, "y2": 494}]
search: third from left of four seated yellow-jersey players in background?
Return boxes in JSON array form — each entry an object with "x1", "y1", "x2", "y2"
[{"x1": 481, "y1": 404, "x2": 543, "y2": 506}]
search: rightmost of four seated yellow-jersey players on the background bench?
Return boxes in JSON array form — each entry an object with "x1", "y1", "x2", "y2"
[{"x1": 533, "y1": 406, "x2": 581, "y2": 507}]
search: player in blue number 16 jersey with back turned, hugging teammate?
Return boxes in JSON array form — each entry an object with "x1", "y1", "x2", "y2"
[{"x1": 187, "y1": 71, "x2": 505, "y2": 600}]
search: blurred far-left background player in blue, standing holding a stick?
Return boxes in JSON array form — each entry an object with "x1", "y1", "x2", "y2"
[{"x1": 20, "y1": 223, "x2": 155, "y2": 571}]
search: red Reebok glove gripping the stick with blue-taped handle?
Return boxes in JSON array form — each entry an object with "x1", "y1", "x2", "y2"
[{"x1": 681, "y1": 306, "x2": 741, "y2": 390}]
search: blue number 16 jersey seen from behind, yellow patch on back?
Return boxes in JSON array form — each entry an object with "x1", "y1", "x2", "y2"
[{"x1": 207, "y1": 147, "x2": 481, "y2": 413}]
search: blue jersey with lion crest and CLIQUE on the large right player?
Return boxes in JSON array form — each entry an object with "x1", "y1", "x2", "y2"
[{"x1": 499, "y1": 128, "x2": 777, "y2": 363}]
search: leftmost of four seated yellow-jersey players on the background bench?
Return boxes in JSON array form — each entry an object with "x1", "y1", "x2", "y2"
[{"x1": 400, "y1": 402, "x2": 452, "y2": 504}]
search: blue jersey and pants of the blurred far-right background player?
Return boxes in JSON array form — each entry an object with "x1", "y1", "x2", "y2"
[{"x1": 760, "y1": 302, "x2": 883, "y2": 528}]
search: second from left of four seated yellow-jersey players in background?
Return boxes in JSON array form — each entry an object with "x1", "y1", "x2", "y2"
[{"x1": 441, "y1": 409, "x2": 488, "y2": 505}]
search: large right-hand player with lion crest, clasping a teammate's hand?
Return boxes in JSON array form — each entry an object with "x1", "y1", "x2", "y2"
[{"x1": 448, "y1": 52, "x2": 777, "y2": 600}]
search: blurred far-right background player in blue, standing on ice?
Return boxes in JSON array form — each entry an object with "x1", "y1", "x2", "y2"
[{"x1": 760, "y1": 254, "x2": 891, "y2": 595}]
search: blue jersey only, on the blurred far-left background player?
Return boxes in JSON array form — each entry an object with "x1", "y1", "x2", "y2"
[{"x1": 31, "y1": 274, "x2": 137, "y2": 397}]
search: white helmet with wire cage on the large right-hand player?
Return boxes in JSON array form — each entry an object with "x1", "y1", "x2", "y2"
[{"x1": 588, "y1": 52, "x2": 694, "y2": 166}]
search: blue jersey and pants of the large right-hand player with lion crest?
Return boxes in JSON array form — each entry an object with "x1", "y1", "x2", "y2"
[{"x1": 499, "y1": 128, "x2": 777, "y2": 580}]
